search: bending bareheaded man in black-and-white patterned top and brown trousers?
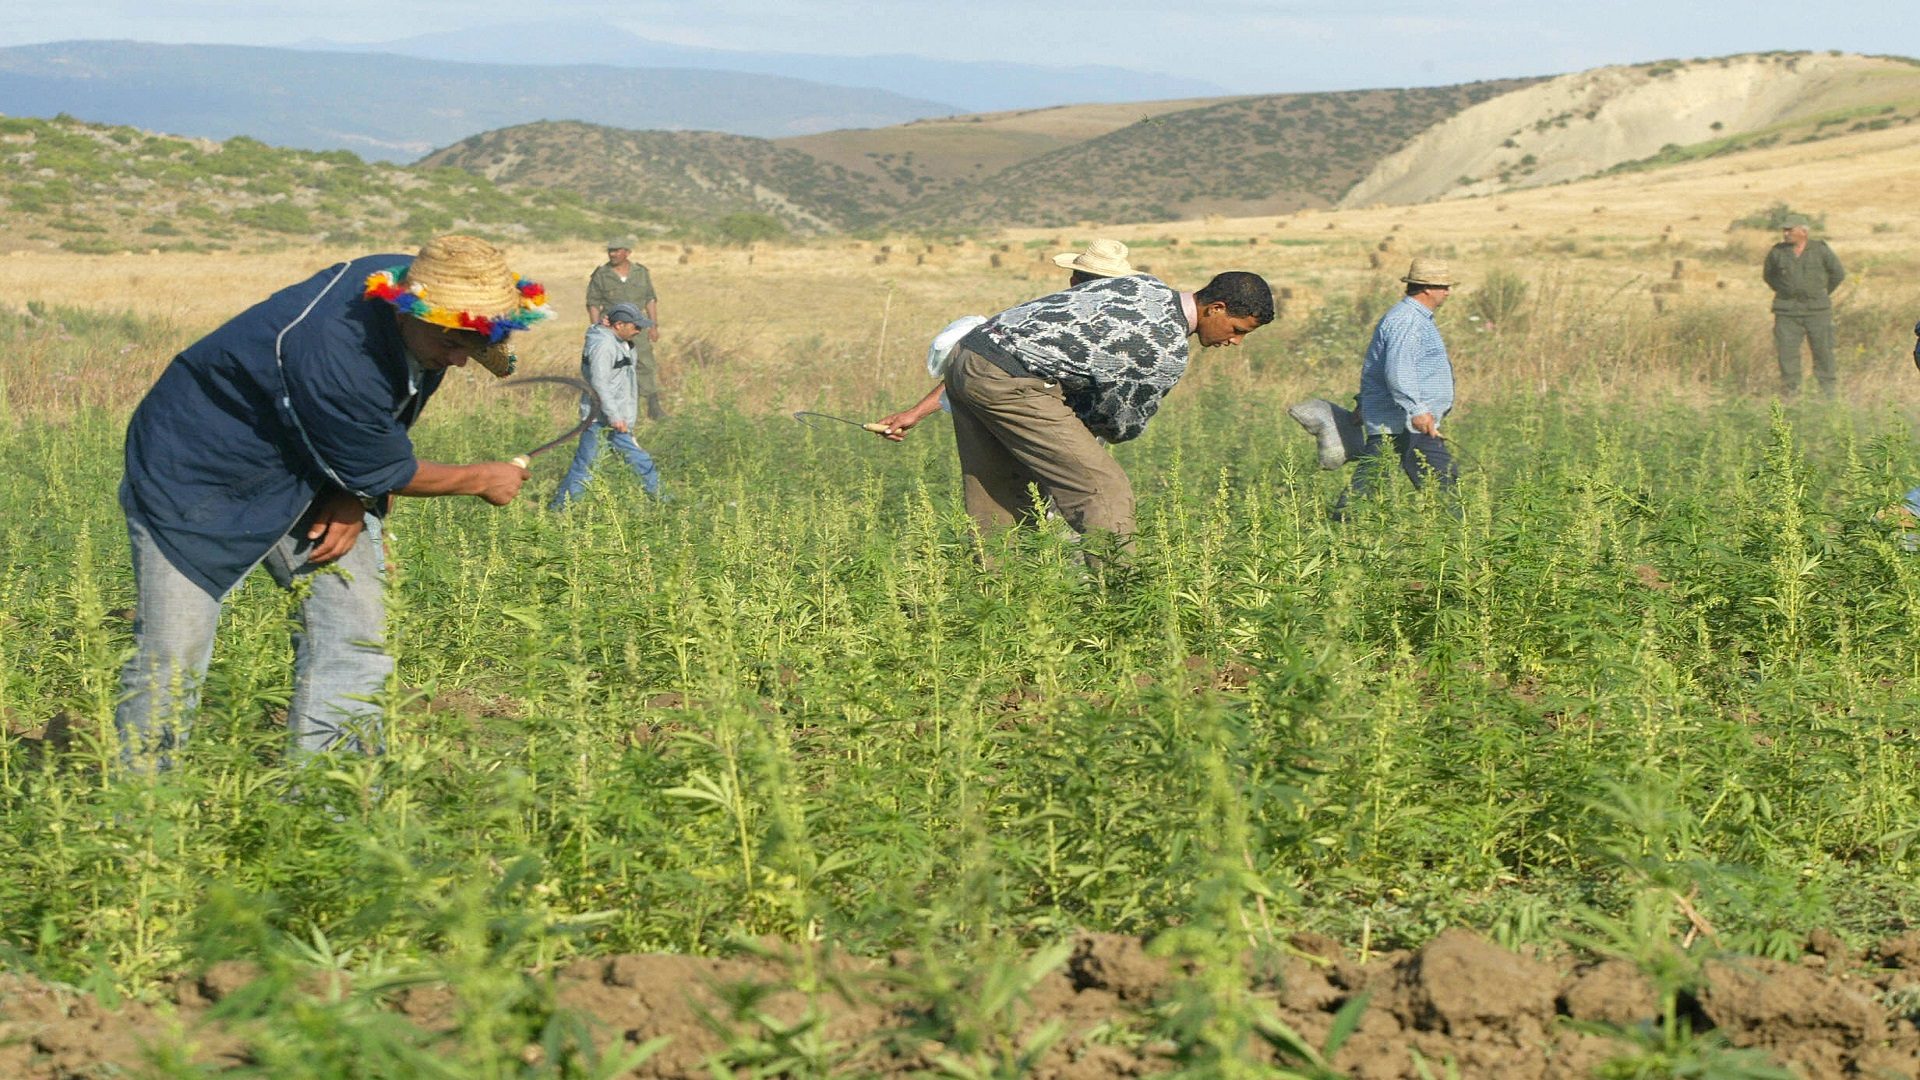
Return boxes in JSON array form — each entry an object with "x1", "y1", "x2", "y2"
[{"x1": 947, "y1": 271, "x2": 1273, "y2": 542}]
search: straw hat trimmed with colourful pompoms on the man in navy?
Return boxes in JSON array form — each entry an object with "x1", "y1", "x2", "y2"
[{"x1": 367, "y1": 234, "x2": 553, "y2": 377}]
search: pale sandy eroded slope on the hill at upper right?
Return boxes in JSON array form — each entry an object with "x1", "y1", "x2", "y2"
[{"x1": 1340, "y1": 54, "x2": 1920, "y2": 206}]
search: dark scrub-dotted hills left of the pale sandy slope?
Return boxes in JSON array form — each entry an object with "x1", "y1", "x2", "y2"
[{"x1": 422, "y1": 79, "x2": 1530, "y2": 231}]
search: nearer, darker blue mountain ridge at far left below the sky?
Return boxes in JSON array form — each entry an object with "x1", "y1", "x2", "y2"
[{"x1": 0, "y1": 40, "x2": 956, "y2": 161}]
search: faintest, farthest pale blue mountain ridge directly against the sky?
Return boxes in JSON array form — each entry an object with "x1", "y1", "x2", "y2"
[{"x1": 296, "y1": 21, "x2": 1225, "y2": 114}]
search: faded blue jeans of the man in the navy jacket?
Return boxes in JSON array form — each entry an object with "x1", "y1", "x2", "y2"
[{"x1": 113, "y1": 513, "x2": 394, "y2": 771}]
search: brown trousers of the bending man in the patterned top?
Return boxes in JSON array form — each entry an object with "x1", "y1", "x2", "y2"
[{"x1": 947, "y1": 350, "x2": 1133, "y2": 540}]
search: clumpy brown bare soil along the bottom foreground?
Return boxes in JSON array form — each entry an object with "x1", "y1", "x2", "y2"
[{"x1": 0, "y1": 930, "x2": 1920, "y2": 1080}]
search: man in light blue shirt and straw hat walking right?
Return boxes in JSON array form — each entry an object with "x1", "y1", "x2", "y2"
[{"x1": 1338, "y1": 258, "x2": 1457, "y2": 509}]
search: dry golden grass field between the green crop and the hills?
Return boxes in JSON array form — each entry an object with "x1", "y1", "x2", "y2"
[{"x1": 11, "y1": 115, "x2": 1920, "y2": 422}]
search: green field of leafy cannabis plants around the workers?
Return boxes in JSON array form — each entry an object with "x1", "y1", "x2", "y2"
[{"x1": 0, "y1": 278, "x2": 1920, "y2": 1076}]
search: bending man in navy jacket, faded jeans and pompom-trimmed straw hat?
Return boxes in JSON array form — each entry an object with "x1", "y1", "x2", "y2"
[{"x1": 115, "y1": 236, "x2": 547, "y2": 769}]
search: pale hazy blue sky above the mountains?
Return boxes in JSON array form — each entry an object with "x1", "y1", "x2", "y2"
[{"x1": 0, "y1": 0, "x2": 1920, "y2": 98}]
